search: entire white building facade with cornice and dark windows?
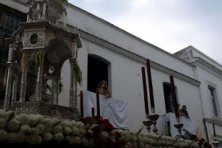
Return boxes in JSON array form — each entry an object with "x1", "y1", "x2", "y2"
[{"x1": 0, "y1": 0, "x2": 222, "y2": 145}]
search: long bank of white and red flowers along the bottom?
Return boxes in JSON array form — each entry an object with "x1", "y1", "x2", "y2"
[{"x1": 0, "y1": 110, "x2": 204, "y2": 148}]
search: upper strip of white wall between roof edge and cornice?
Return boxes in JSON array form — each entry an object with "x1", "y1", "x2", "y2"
[{"x1": 67, "y1": 5, "x2": 194, "y2": 78}]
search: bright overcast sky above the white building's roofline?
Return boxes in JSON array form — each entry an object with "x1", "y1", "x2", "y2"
[{"x1": 68, "y1": 0, "x2": 222, "y2": 64}]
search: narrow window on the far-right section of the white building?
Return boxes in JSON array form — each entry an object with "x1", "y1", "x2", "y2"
[{"x1": 208, "y1": 85, "x2": 218, "y2": 116}]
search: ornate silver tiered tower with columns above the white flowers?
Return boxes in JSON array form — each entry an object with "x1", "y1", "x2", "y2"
[{"x1": 4, "y1": 0, "x2": 81, "y2": 118}]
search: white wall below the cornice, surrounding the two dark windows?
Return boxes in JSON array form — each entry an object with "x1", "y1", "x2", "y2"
[{"x1": 60, "y1": 39, "x2": 205, "y2": 131}]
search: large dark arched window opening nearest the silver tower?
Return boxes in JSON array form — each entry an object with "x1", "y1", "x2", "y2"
[{"x1": 87, "y1": 54, "x2": 110, "y2": 92}]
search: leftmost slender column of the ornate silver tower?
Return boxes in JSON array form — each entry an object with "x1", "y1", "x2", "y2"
[{"x1": 4, "y1": 44, "x2": 13, "y2": 110}]
